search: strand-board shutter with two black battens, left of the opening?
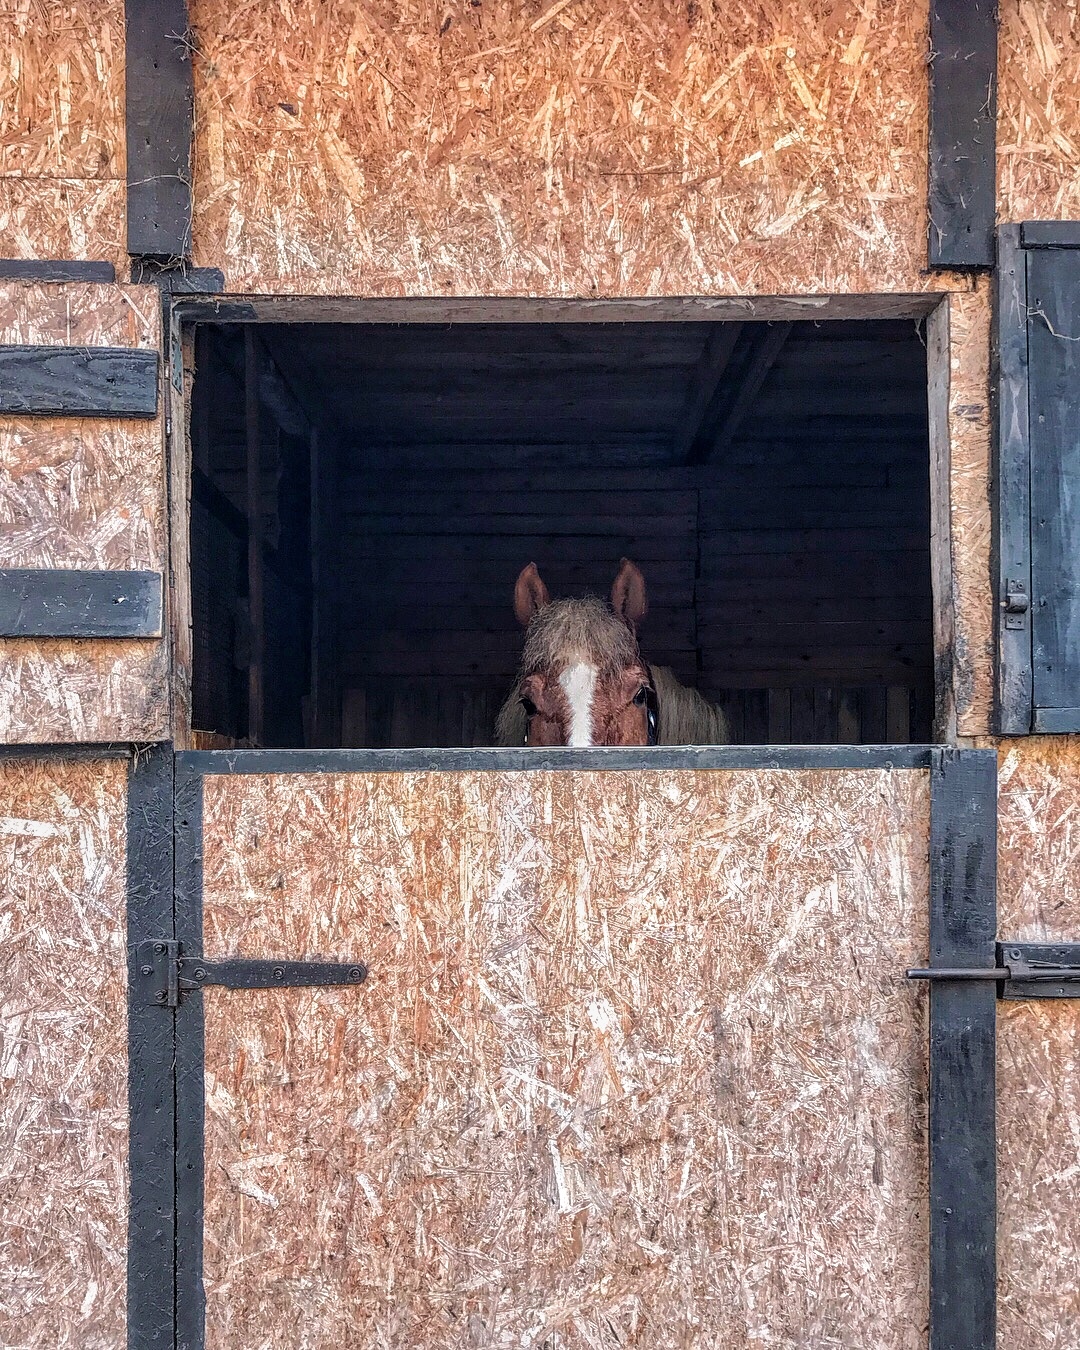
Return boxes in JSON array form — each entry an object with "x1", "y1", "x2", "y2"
[{"x1": 0, "y1": 279, "x2": 169, "y2": 744}]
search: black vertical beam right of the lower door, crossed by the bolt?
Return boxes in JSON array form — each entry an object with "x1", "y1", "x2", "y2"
[{"x1": 930, "y1": 748, "x2": 998, "y2": 1350}]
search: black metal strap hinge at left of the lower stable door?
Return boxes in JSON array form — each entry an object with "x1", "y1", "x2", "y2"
[{"x1": 135, "y1": 942, "x2": 367, "y2": 1008}]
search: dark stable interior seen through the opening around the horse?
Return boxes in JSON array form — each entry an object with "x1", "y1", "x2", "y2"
[{"x1": 190, "y1": 320, "x2": 934, "y2": 747}]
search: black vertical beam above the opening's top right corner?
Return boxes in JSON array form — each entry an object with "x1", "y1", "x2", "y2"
[{"x1": 929, "y1": 0, "x2": 998, "y2": 267}]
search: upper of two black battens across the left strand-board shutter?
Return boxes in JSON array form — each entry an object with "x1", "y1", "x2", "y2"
[{"x1": 0, "y1": 346, "x2": 158, "y2": 417}]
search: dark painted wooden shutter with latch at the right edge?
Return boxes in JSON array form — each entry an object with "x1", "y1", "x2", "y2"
[{"x1": 995, "y1": 221, "x2": 1080, "y2": 734}]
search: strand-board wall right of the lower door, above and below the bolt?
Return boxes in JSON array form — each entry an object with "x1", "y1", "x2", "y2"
[{"x1": 998, "y1": 736, "x2": 1080, "y2": 1350}]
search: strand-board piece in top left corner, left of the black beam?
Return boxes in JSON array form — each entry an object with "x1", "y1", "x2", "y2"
[{"x1": 0, "y1": 0, "x2": 127, "y2": 275}]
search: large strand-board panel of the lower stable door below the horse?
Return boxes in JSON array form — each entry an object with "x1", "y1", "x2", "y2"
[{"x1": 204, "y1": 771, "x2": 929, "y2": 1350}]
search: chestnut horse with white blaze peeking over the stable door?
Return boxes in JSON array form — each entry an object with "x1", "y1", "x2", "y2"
[{"x1": 495, "y1": 558, "x2": 730, "y2": 745}]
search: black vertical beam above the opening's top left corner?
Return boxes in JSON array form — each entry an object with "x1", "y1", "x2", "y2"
[{"x1": 124, "y1": 0, "x2": 194, "y2": 259}]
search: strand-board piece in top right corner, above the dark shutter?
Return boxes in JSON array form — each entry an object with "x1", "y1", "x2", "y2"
[{"x1": 998, "y1": 0, "x2": 1080, "y2": 220}]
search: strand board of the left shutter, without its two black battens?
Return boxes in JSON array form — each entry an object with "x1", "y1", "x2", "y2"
[{"x1": 0, "y1": 282, "x2": 169, "y2": 741}]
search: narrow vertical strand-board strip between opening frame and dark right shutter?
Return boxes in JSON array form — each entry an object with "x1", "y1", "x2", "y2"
[{"x1": 948, "y1": 277, "x2": 994, "y2": 736}]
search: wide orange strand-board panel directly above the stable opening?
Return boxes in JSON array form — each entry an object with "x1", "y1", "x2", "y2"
[{"x1": 190, "y1": 0, "x2": 967, "y2": 296}]
